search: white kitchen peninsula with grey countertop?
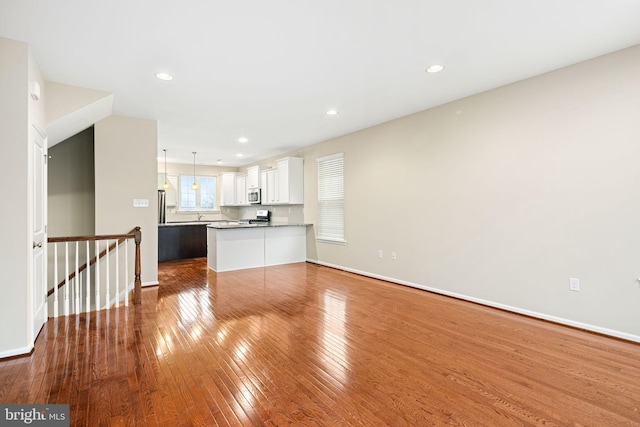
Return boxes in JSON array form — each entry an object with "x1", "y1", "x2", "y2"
[{"x1": 207, "y1": 221, "x2": 308, "y2": 272}]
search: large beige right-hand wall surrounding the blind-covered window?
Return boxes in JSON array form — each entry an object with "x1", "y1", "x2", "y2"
[{"x1": 290, "y1": 46, "x2": 640, "y2": 340}]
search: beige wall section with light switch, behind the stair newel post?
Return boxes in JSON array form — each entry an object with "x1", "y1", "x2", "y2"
[{"x1": 95, "y1": 116, "x2": 158, "y2": 285}]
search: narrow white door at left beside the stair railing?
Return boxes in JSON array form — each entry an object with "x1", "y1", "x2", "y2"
[{"x1": 30, "y1": 126, "x2": 47, "y2": 341}]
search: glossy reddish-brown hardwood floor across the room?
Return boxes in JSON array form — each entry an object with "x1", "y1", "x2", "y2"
[{"x1": 0, "y1": 259, "x2": 640, "y2": 427}]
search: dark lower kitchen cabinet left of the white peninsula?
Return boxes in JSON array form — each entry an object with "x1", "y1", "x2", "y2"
[{"x1": 158, "y1": 224, "x2": 207, "y2": 261}]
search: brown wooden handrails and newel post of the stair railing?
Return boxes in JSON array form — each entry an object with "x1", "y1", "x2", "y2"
[{"x1": 47, "y1": 227, "x2": 142, "y2": 304}]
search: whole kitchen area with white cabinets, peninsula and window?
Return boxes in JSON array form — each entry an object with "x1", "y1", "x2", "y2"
[{"x1": 158, "y1": 157, "x2": 309, "y2": 272}]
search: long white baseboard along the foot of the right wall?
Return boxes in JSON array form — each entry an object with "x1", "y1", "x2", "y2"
[{"x1": 307, "y1": 259, "x2": 640, "y2": 343}]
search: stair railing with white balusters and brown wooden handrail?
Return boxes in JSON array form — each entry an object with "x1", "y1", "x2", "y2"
[{"x1": 47, "y1": 227, "x2": 142, "y2": 317}]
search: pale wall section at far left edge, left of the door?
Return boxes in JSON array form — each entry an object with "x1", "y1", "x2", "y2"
[{"x1": 0, "y1": 38, "x2": 31, "y2": 356}]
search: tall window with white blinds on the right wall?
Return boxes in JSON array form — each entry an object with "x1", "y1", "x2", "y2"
[{"x1": 317, "y1": 153, "x2": 346, "y2": 243}]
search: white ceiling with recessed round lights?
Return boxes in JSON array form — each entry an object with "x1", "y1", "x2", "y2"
[{"x1": 0, "y1": 0, "x2": 640, "y2": 166}]
